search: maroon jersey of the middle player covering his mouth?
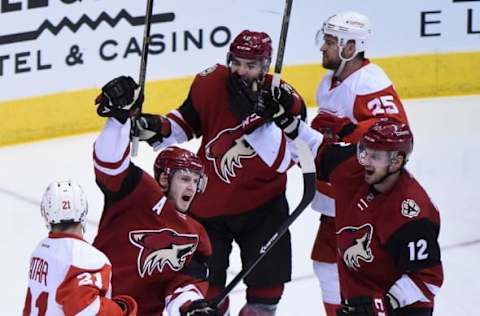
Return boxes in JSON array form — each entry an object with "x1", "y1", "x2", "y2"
[{"x1": 168, "y1": 64, "x2": 305, "y2": 217}]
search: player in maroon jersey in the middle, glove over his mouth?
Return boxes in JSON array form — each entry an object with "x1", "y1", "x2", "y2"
[{"x1": 100, "y1": 31, "x2": 305, "y2": 316}]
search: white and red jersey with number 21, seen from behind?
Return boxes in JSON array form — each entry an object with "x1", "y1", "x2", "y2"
[{"x1": 23, "y1": 232, "x2": 122, "y2": 316}]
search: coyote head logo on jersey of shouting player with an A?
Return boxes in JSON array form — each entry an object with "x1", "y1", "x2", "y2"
[{"x1": 129, "y1": 228, "x2": 198, "y2": 278}]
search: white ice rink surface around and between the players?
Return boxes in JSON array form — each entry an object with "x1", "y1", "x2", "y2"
[{"x1": 0, "y1": 95, "x2": 480, "y2": 316}]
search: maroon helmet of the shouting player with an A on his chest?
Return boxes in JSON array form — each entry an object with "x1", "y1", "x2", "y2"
[{"x1": 153, "y1": 146, "x2": 208, "y2": 192}]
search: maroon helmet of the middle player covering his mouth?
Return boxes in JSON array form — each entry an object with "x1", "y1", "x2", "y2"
[{"x1": 229, "y1": 30, "x2": 272, "y2": 63}]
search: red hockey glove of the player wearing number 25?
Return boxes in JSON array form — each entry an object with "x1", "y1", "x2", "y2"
[{"x1": 311, "y1": 111, "x2": 357, "y2": 139}]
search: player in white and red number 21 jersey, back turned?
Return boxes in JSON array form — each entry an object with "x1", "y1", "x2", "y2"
[{"x1": 23, "y1": 181, "x2": 137, "y2": 316}]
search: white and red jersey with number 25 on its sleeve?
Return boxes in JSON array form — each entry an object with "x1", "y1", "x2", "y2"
[{"x1": 312, "y1": 60, "x2": 407, "y2": 216}]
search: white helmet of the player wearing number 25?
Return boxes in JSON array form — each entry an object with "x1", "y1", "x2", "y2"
[{"x1": 317, "y1": 11, "x2": 372, "y2": 55}]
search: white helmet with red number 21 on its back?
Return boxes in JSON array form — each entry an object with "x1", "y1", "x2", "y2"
[{"x1": 40, "y1": 180, "x2": 88, "y2": 230}]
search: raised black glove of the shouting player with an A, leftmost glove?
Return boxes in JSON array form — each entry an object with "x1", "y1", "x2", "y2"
[{"x1": 95, "y1": 76, "x2": 143, "y2": 124}]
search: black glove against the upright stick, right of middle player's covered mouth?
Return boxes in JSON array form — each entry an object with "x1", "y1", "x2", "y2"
[{"x1": 254, "y1": 86, "x2": 300, "y2": 139}]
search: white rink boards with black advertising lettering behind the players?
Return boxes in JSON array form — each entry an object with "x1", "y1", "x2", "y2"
[{"x1": 0, "y1": 0, "x2": 480, "y2": 101}]
